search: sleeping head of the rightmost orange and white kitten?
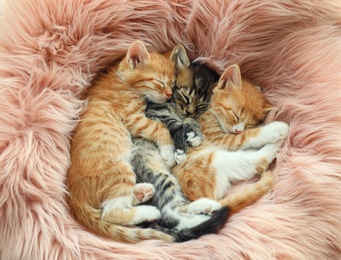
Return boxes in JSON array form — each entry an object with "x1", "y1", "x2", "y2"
[{"x1": 209, "y1": 64, "x2": 273, "y2": 134}]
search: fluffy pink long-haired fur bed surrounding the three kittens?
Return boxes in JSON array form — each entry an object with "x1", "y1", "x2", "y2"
[{"x1": 0, "y1": 0, "x2": 341, "y2": 260}]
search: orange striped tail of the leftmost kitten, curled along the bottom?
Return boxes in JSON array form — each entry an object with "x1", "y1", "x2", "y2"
[{"x1": 70, "y1": 204, "x2": 176, "y2": 243}]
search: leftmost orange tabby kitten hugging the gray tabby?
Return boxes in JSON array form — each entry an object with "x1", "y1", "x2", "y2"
[{"x1": 67, "y1": 41, "x2": 181, "y2": 242}]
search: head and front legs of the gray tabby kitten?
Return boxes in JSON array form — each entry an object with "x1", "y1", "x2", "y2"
[{"x1": 145, "y1": 62, "x2": 219, "y2": 155}]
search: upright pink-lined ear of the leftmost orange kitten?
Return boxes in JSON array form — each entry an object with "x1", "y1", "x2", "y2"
[{"x1": 126, "y1": 40, "x2": 150, "y2": 69}]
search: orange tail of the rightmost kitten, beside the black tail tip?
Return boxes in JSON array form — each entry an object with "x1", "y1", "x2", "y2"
[{"x1": 219, "y1": 171, "x2": 274, "y2": 217}]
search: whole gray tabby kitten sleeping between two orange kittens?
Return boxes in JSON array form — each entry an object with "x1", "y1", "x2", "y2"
[{"x1": 132, "y1": 45, "x2": 223, "y2": 241}]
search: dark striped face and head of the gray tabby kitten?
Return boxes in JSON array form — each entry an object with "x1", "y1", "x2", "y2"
[{"x1": 172, "y1": 60, "x2": 219, "y2": 118}]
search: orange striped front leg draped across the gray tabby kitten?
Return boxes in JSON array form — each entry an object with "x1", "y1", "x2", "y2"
[{"x1": 124, "y1": 113, "x2": 175, "y2": 167}]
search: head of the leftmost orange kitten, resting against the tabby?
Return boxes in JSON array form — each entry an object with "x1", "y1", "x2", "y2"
[{"x1": 117, "y1": 41, "x2": 185, "y2": 103}]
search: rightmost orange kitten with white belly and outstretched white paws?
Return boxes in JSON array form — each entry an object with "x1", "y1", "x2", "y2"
[{"x1": 172, "y1": 65, "x2": 288, "y2": 214}]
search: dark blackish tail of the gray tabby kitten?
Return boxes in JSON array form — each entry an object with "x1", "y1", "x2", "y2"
[{"x1": 152, "y1": 207, "x2": 229, "y2": 242}]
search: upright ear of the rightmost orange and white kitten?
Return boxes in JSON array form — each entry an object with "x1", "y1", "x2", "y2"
[{"x1": 215, "y1": 64, "x2": 243, "y2": 90}]
